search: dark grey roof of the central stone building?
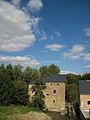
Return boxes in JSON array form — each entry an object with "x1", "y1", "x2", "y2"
[{"x1": 44, "y1": 74, "x2": 66, "y2": 83}]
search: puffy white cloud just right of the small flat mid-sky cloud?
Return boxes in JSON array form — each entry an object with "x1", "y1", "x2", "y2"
[{"x1": 64, "y1": 44, "x2": 85, "y2": 60}]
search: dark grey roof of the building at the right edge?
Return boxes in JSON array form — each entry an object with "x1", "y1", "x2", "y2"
[{"x1": 79, "y1": 80, "x2": 90, "y2": 94}]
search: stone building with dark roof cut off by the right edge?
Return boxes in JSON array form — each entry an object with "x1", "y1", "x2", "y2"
[{"x1": 79, "y1": 80, "x2": 90, "y2": 118}]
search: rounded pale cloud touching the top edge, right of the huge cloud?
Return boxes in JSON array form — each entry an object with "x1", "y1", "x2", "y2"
[{"x1": 28, "y1": 0, "x2": 43, "y2": 12}]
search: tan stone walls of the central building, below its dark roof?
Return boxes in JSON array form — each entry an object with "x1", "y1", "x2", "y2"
[{"x1": 29, "y1": 83, "x2": 65, "y2": 112}]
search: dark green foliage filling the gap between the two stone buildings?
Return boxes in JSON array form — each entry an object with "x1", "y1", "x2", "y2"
[{"x1": 65, "y1": 74, "x2": 81, "y2": 105}]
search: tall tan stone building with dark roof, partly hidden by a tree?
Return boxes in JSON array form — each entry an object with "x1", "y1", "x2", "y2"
[{"x1": 29, "y1": 75, "x2": 65, "y2": 112}]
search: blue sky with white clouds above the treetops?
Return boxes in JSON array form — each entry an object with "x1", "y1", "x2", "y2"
[{"x1": 0, "y1": 0, "x2": 90, "y2": 74}]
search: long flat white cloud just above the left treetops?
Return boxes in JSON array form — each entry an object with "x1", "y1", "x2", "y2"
[{"x1": 0, "y1": 56, "x2": 40, "y2": 67}]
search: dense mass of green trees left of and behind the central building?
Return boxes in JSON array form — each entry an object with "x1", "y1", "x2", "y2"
[{"x1": 0, "y1": 64, "x2": 60, "y2": 109}]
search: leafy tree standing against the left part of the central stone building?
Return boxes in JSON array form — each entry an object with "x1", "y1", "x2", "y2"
[{"x1": 32, "y1": 80, "x2": 46, "y2": 110}]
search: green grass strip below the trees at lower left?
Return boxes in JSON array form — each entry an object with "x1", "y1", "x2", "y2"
[{"x1": 0, "y1": 106, "x2": 39, "y2": 120}]
